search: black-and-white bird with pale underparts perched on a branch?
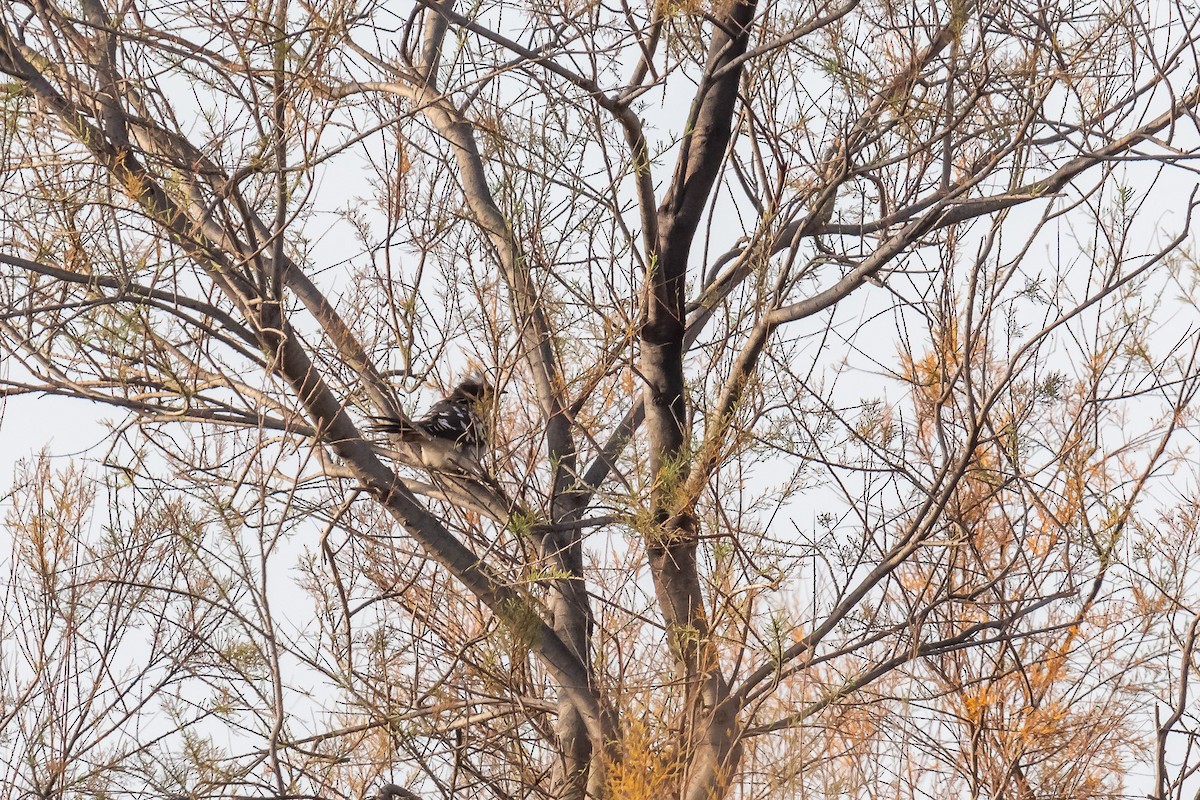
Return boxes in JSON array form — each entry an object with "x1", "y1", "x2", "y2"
[{"x1": 370, "y1": 373, "x2": 496, "y2": 473}]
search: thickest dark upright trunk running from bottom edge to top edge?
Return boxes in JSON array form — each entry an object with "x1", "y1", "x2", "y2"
[{"x1": 641, "y1": 1, "x2": 756, "y2": 800}]
